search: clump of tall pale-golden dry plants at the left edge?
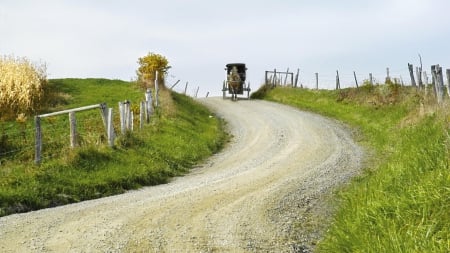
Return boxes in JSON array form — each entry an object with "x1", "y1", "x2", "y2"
[{"x1": 0, "y1": 56, "x2": 47, "y2": 117}]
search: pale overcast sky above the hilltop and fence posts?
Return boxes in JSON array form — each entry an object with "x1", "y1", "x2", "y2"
[{"x1": 0, "y1": 0, "x2": 450, "y2": 96}]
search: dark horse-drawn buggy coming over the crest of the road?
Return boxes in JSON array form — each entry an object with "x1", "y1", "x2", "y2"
[{"x1": 222, "y1": 63, "x2": 250, "y2": 101}]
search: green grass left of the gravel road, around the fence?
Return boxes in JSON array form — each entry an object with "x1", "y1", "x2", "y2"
[{"x1": 0, "y1": 79, "x2": 227, "y2": 216}]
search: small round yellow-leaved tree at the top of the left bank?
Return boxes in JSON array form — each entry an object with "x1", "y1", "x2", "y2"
[{"x1": 136, "y1": 53, "x2": 171, "y2": 88}]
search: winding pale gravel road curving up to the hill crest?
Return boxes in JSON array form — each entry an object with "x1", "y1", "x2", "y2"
[{"x1": 0, "y1": 98, "x2": 361, "y2": 252}]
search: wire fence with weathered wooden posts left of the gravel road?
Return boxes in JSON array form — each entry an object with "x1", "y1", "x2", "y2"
[{"x1": 0, "y1": 91, "x2": 156, "y2": 165}]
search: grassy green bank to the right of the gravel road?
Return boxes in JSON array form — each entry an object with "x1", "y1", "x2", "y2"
[{"x1": 255, "y1": 85, "x2": 450, "y2": 252}]
